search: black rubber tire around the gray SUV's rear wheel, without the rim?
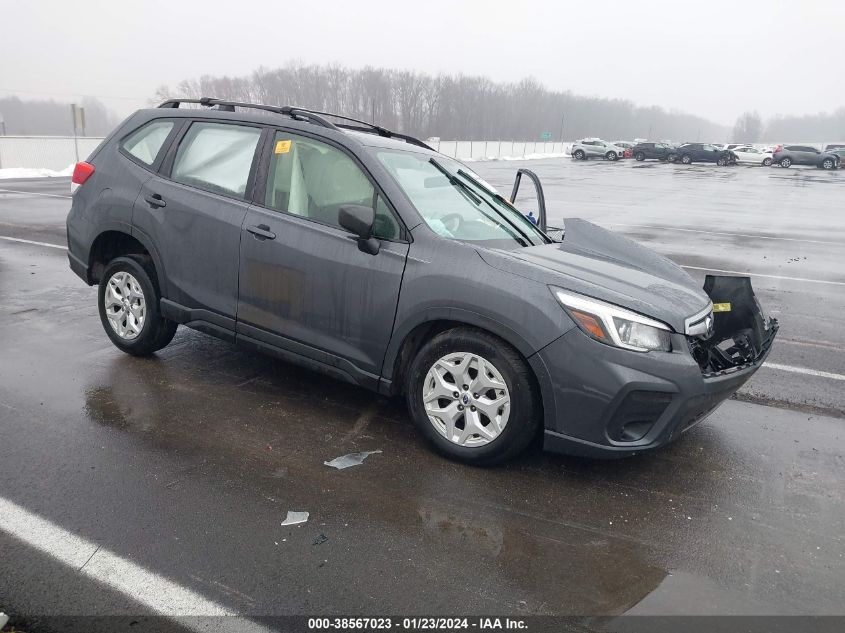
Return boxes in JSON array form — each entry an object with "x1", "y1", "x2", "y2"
[{"x1": 97, "y1": 255, "x2": 178, "y2": 356}]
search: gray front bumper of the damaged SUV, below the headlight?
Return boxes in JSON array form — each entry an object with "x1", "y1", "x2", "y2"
[{"x1": 537, "y1": 325, "x2": 777, "y2": 458}]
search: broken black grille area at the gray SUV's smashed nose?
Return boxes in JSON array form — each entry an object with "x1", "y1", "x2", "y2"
[{"x1": 686, "y1": 275, "x2": 778, "y2": 378}]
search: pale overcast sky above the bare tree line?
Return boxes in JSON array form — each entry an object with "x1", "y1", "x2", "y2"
[{"x1": 0, "y1": 0, "x2": 845, "y2": 124}]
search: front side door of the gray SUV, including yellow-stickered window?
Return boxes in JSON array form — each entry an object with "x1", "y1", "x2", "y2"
[{"x1": 237, "y1": 130, "x2": 408, "y2": 382}]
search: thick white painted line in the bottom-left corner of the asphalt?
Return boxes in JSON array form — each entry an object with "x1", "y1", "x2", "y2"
[{"x1": 0, "y1": 497, "x2": 270, "y2": 633}]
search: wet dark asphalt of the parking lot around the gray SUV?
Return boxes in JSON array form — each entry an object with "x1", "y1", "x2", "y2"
[{"x1": 0, "y1": 159, "x2": 845, "y2": 630}]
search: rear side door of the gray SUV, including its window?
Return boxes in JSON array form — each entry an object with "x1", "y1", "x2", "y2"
[{"x1": 133, "y1": 120, "x2": 261, "y2": 330}]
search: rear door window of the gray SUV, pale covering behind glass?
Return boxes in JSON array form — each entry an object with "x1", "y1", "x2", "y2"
[{"x1": 171, "y1": 123, "x2": 261, "y2": 199}]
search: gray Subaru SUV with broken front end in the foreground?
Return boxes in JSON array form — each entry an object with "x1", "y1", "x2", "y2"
[{"x1": 67, "y1": 98, "x2": 777, "y2": 463}]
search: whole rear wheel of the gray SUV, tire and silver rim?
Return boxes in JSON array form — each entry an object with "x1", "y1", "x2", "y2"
[{"x1": 97, "y1": 256, "x2": 177, "y2": 356}]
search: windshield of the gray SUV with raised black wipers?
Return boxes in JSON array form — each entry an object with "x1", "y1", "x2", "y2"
[{"x1": 377, "y1": 150, "x2": 551, "y2": 249}]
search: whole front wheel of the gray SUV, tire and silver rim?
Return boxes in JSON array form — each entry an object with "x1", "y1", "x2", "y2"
[{"x1": 406, "y1": 327, "x2": 541, "y2": 464}]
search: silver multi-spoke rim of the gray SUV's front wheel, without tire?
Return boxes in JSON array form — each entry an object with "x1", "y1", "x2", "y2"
[{"x1": 422, "y1": 352, "x2": 511, "y2": 448}]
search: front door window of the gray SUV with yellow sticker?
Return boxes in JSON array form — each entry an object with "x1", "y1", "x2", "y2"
[{"x1": 264, "y1": 132, "x2": 399, "y2": 239}]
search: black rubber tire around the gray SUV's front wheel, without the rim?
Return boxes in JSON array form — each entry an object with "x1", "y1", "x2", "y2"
[{"x1": 405, "y1": 327, "x2": 542, "y2": 465}]
